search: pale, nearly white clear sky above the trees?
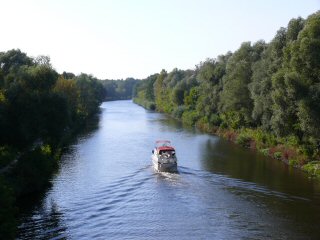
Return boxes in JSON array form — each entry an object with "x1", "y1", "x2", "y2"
[{"x1": 0, "y1": 0, "x2": 320, "y2": 79}]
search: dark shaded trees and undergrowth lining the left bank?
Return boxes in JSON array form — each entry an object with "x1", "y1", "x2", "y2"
[{"x1": 0, "y1": 50, "x2": 105, "y2": 239}]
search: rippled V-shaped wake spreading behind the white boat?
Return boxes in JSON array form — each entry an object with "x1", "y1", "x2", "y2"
[{"x1": 20, "y1": 163, "x2": 316, "y2": 239}]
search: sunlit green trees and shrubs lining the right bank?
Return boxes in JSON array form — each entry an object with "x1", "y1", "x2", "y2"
[{"x1": 134, "y1": 12, "x2": 320, "y2": 174}]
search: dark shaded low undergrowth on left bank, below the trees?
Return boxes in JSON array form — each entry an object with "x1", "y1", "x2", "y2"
[{"x1": 0, "y1": 113, "x2": 99, "y2": 239}]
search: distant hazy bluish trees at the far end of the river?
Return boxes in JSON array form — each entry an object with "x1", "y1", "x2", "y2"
[{"x1": 101, "y1": 78, "x2": 139, "y2": 101}]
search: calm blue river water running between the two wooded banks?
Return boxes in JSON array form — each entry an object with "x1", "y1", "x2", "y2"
[{"x1": 18, "y1": 101, "x2": 320, "y2": 239}]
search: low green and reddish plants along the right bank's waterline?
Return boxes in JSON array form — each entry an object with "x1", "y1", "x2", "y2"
[{"x1": 133, "y1": 98, "x2": 320, "y2": 180}]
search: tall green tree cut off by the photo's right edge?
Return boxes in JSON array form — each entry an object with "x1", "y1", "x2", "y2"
[{"x1": 285, "y1": 11, "x2": 320, "y2": 141}]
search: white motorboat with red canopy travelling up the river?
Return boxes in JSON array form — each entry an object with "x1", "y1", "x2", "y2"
[{"x1": 151, "y1": 140, "x2": 177, "y2": 172}]
